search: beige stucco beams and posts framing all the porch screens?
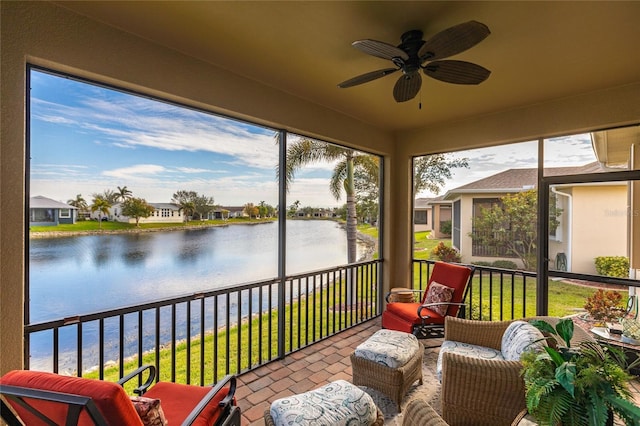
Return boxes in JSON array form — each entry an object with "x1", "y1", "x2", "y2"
[{"x1": 0, "y1": 1, "x2": 640, "y2": 374}]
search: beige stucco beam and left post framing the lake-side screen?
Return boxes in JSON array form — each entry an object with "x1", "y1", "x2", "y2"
[{"x1": 0, "y1": 1, "x2": 396, "y2": 374}]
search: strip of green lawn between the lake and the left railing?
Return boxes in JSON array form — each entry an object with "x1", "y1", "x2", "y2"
[{"x1": 84, "y1": 272, "x2": 376, "y2": 393}]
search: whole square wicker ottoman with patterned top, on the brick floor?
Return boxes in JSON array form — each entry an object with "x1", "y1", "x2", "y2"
[{"x1": 351, "y1": 330, "x2": 424, "y2": 412}]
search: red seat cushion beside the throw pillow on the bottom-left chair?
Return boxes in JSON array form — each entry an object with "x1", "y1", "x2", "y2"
[{"x1": 144, "y1": 382, "x2": 229, "y2": 426}]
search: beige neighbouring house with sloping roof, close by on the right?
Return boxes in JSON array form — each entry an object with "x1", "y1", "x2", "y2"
[{"x1": 443, "y1": 162, "x2": 628, "y2": 274}]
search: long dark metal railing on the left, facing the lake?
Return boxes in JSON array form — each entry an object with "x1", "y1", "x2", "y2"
[{"x1": 25, "y1": 260, "x2": 382, "y2": 385}]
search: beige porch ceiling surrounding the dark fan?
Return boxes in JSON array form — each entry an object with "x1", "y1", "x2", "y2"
[{"x1": 56, "y1": 1, "x2": 640, "y2": 130}]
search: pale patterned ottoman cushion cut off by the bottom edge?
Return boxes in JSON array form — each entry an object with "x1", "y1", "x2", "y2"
[{"x1": 269, "y1": 380, "x2": 377, "y2": 426}]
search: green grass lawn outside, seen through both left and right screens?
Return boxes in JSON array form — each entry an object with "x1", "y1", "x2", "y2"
[{"x1": 77, "y1": 226, "x2": 594, "y2": 391}]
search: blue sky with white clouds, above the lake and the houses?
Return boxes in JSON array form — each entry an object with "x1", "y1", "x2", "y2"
[{"x1": 30, "y1": 71, "x2": 595, "y2": 207}]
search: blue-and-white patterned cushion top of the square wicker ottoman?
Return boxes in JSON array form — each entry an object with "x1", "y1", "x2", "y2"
[{"x1": 355, "y1": 329, "x2": 420, "y2": 368}]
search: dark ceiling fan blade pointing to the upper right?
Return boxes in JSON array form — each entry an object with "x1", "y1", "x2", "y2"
[{"x1": 418, "y1": 21, "x2": 491, "y2": 61}]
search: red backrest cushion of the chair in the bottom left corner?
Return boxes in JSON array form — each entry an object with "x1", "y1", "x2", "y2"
[{"x1": 0, "y1": 370, "x2": 142, "y2": 426}]
